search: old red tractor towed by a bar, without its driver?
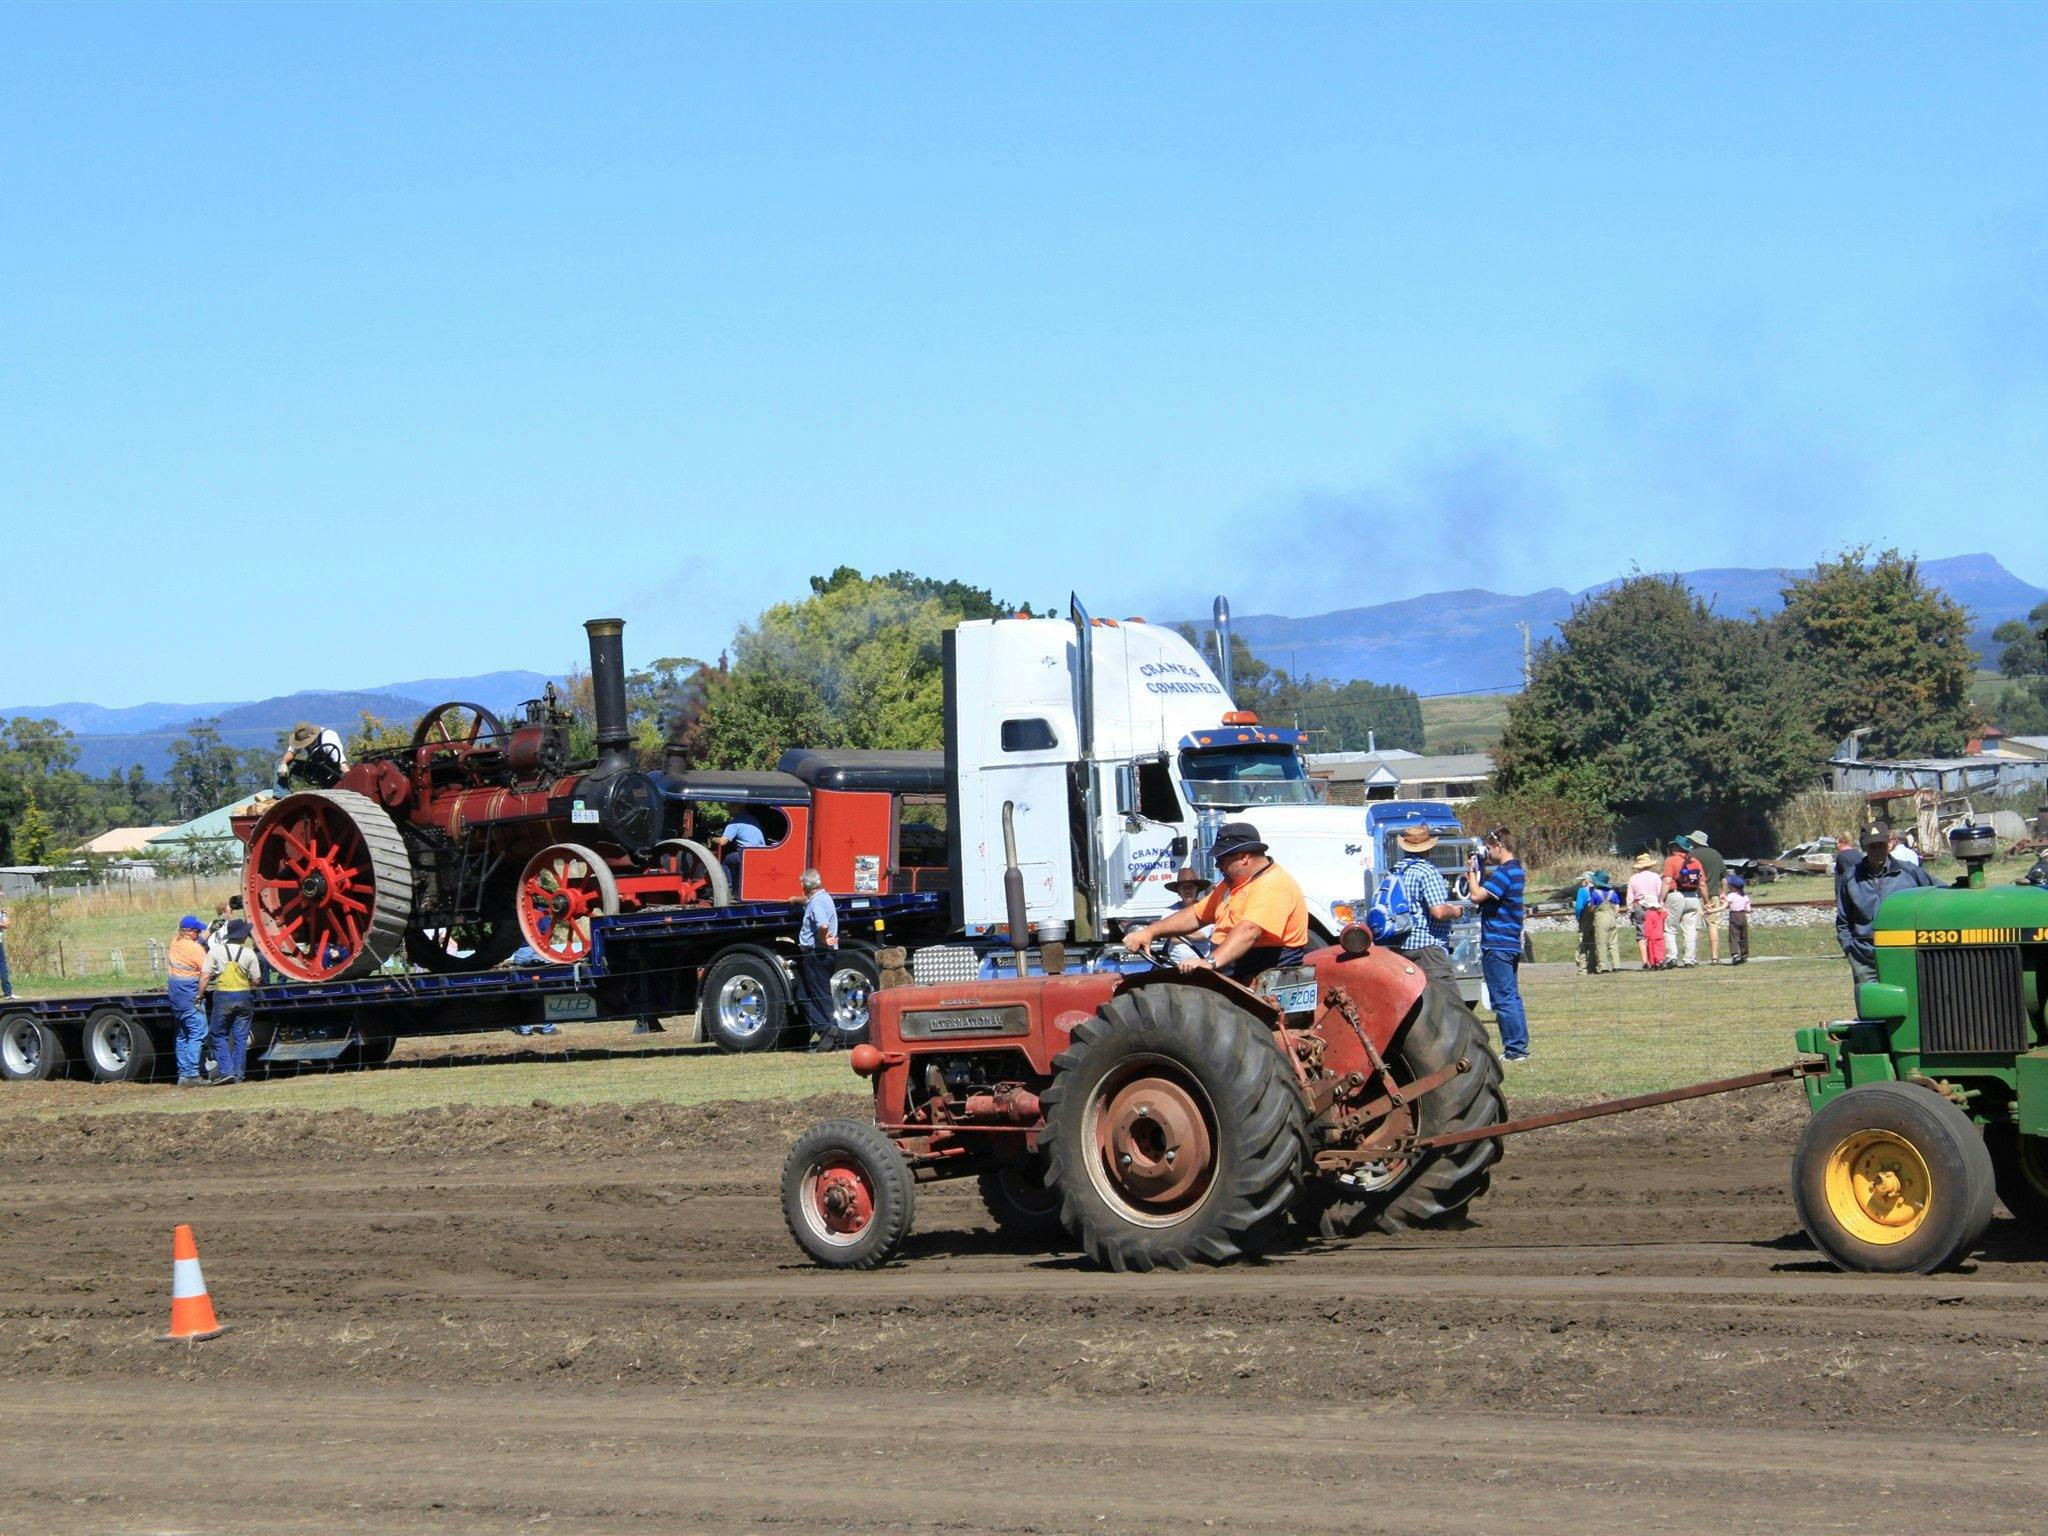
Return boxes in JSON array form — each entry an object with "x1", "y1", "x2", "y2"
[{"x1": 782, "y1": 928, "x2": 1503, "y2": 1270}]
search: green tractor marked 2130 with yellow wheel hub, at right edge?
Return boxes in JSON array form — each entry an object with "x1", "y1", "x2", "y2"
[{"x1": 1792, "y1": 827, "x2": 2048, "y2": 1274}]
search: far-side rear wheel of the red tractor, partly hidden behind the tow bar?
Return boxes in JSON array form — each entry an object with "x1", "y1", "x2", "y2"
[{"x1": 1303, "y1": 981, "x2": 1507, "y2": 1237}]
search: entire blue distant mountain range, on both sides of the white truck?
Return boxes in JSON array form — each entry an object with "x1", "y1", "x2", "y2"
[{"x1": 0, "y1": 555, "x2": 2048, "y2": 776}]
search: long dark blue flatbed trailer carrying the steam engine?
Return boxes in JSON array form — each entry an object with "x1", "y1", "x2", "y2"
[{"x1": 0, "y1": 891, "x2": 946, "y2": 1083}]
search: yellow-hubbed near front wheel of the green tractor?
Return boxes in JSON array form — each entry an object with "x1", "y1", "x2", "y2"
[{"x1": 1792, "y1": 1083, "x2": 1995, "y2": 1274}]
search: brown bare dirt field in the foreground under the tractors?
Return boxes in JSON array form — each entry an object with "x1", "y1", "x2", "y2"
[{"x1": 0, "y1": 1090, "x2": 2048, "y2": 1534}]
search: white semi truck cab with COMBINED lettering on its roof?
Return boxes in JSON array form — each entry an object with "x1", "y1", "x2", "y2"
[{"x1": 946, "y1": 598, "x2": 1368, "y2": 942}]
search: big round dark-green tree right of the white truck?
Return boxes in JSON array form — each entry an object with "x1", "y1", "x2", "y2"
[{"x1": 1497, "y1": 575, "x2": 1825, "y2": 838}]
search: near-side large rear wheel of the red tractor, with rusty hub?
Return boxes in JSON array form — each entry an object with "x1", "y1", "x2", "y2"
[{"x1": 1038, "y1": 983, "x2": 1309, "y2": 1272}]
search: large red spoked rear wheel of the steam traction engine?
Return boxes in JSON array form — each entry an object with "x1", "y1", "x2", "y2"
[{"x1": 244, "y1": 788, "x2": 412, "y2": 981}]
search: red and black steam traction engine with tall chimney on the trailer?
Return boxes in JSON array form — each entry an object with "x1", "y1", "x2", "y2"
[{"x1": 236, "y1": 618, "x2": 731, "y2": 981}]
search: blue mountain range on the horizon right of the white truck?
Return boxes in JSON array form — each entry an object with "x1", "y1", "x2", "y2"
[{"x1": 1198, "y1": 555, "x2": 2048, "y2": 694}]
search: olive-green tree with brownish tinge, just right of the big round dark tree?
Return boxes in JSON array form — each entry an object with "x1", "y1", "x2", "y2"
[{"x1": 1774, "y1": 547, "x2": 1976, "y2": 758}]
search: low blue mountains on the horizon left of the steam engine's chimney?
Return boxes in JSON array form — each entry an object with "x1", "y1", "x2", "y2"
[{"x1": 0, "y1": 672, "x2": 561, "y2": 778}]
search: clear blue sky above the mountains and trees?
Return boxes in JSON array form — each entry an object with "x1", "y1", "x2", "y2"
[{"x1": 0, "y1": 6, "x2": 2048, "y2": 705}]
